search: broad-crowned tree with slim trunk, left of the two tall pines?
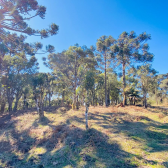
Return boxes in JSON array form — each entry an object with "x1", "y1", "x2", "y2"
[{"x1": 48, "y1": 46, "x2": 96, "y2": 108}]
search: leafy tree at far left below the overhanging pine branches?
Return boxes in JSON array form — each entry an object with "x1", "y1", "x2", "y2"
[{"x1": 1, "y1": 54, "x2": 37, "y2": 112}]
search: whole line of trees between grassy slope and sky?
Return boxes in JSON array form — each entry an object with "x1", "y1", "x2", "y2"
[{"x1": 0, "y1": 0, "x2": 168, "y2": 119}]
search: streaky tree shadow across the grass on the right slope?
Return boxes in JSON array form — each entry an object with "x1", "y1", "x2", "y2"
[{"x1": 92, "y1": 112, "x2": 168, "y2": 152}]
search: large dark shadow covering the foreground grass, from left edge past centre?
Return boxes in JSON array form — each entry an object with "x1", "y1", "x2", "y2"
[{"x1": 0, "y1": 119, "x2": 137, "y2": 168}]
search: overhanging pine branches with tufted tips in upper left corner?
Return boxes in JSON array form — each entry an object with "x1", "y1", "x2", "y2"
[{"x1": 0, "y1": 0, "x2": 59, "y2": 71}]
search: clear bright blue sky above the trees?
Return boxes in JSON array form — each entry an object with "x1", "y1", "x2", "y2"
[{"x1": 27, "y1": 0, "x2": 168, "y2": 74}]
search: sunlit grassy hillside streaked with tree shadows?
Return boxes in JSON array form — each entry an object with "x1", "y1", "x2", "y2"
[{"x1": 0, "y1": 106, "x2": 168, "y2": 168}]
